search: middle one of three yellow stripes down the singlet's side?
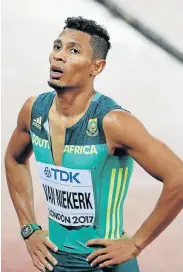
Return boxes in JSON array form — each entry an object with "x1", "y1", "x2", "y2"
[{"x1": 111, "y1": 168, "x2": 123, "y2": 239}]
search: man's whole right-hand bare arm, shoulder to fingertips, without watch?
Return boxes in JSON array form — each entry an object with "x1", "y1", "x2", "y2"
[{"x1": 87, "y1": 111, "x2": 183, "y2": 267}]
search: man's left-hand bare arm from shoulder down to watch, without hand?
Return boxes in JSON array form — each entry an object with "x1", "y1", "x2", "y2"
[{"x1": 5, "y1": 97, "x2": 36, "y2": 227}]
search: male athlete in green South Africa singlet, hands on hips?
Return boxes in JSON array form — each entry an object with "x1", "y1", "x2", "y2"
[{"x1": 5, "y1": 17, "x2": 183, "y2": 272}]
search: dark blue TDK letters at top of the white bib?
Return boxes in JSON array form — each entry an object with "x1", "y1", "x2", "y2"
[{"x1": 51, "y1": 168, "x2": 80, "y2": 183}]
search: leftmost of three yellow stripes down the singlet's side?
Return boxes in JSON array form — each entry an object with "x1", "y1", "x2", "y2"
[{"x1": 105, "y1": 168, "x2": 116, "y2": 239}]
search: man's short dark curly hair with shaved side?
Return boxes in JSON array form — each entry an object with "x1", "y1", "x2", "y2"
[{"x1": 64, "y1": 16, "x2": 111, "y2": 59}]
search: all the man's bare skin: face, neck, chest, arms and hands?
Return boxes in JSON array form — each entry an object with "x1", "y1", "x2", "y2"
[{"x1": 5, "y1": 29, "x2": 183, "y2": 271}]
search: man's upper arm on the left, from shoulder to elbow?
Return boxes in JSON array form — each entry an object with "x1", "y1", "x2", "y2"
[{"x1": 5, "y1": 97, "x2": 35, "y2": 163}]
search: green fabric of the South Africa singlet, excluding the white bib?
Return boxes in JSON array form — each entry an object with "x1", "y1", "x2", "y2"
[{"x1": 30, "y1": 92, "x2": 133, "y2": 253}]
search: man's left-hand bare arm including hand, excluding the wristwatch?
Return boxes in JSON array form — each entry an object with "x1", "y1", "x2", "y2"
[{"x1": 5, "y1": 97, "x2": 58, "y2": 271}]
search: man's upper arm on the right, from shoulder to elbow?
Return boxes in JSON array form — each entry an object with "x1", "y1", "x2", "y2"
[{"x1": 103, "y1": 111, "x2": 183, "y2": 181}]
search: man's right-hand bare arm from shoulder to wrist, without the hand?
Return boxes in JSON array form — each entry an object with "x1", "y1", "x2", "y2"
[{"x1": 104, "y1": 111, "x2": 183, "y2": 249}]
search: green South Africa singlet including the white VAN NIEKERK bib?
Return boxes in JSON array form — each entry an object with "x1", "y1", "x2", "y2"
[{"x1": 30, "y1": 92, "x2": 133, "y2": 254}]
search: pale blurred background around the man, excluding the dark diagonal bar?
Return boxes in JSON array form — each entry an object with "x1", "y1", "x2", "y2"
[{"x1": 1, "y1": 0, "x2": 183, "y2": 272}]
